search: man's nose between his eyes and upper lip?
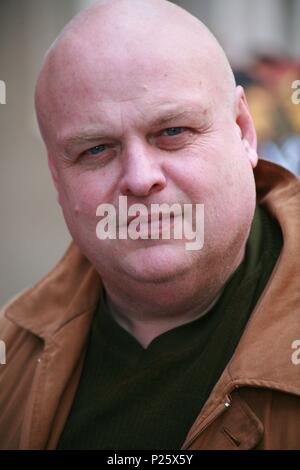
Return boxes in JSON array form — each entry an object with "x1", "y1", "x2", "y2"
[{"x1": 120, "y1": 143, "x2": 166, "y2": 197}]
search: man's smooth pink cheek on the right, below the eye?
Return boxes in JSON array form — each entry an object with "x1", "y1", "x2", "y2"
[{"x1": 169, "y1": 133, "x2": 255, "y2": 218}]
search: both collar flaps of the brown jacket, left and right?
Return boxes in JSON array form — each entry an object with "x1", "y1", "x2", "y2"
[{"x1": 5, "y1": 160, "x2": 300, "y2": 392}]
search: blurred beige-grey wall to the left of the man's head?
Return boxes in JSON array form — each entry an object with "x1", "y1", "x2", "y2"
[{"x1": 0, "y1": 0, "x2": 74, "y2": 305}]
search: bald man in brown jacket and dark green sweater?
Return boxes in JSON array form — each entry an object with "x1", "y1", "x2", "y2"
[{"x1": 0, "y1": 0, "x2": 300, "y2": 450}]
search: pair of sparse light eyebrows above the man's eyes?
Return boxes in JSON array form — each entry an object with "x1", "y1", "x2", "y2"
[{"x1": 61, "y1": 105, "x2": 207, "y2": 149}]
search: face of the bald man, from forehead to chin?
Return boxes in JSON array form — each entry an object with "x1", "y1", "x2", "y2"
[{"x1": 45, "y1": 44, "x2": 255, "y2": 282}]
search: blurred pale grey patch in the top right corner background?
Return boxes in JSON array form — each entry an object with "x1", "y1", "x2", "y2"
[{"x1": 173, "y1": 0, "x2": 300, "y2": 64}]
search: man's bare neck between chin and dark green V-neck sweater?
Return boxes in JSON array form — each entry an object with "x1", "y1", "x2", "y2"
[{"x1": 103, "y1": 242, "x2": 245, "y2": 347}]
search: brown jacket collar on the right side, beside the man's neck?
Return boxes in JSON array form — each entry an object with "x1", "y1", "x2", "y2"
[{"x1": 228, "y1": 161, "x2": 300, "y2": 395}]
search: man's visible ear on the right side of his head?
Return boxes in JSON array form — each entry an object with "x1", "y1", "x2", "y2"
[{"x1": 235, "y1": 86, "x2": 258, "y2": 168}]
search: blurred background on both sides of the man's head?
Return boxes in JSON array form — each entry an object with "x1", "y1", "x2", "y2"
[{"x1": 0, "y1": 0, "x2": 300, "y2": 305}]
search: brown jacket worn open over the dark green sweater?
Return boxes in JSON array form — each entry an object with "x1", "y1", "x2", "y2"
[{"x1": 0, "y1": 162, "x2": 300, "y2": 450}]
